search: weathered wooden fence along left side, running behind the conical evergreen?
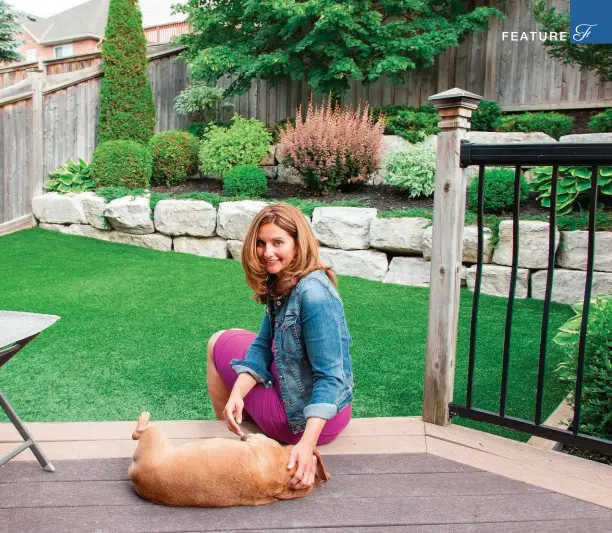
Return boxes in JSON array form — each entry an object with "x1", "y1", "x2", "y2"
[{"x1": 0, "y1": 47, "x2": 187, "y2": 232}]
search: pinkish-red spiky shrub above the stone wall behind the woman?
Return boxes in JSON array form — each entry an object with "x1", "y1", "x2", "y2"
[{"x1": 278, "y1": 101, "x2": 385, "y2": 192}]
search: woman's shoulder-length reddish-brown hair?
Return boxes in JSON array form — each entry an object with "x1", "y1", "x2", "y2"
[{"x1": 241, "y1": 203, "x2": 338, "y2": 303}]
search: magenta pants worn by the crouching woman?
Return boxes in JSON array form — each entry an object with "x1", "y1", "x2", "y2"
[{"x1": 213, "y1": 329, "x2": 352, "y2": 445}]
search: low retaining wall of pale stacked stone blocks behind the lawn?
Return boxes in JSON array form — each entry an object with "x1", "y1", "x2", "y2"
[{"x1": 32, "y1": 192, "x2": 612, "y2": 304}]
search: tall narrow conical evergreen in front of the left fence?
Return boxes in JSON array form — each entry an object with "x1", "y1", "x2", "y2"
[{"x1": 98, "y1": 0, "x2": 156, "y2": 143}]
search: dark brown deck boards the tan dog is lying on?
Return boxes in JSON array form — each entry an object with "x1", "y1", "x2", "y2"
[{"x1": 0, "y1": 454, "x2": 612, "y2": 533}]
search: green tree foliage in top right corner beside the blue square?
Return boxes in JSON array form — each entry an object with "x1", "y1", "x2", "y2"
[{"x1": 532, "y1": 0, "x2": 612, "y2": 80}]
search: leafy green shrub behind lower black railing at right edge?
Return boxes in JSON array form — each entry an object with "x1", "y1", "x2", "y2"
[{"x1": 553, "y1": 295, "x2": 612, "y2": 439}]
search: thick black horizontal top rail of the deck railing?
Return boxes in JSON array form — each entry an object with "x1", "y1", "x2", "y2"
[{"x1": 460, "y1": 140, "x2": 612, "y2": 167}]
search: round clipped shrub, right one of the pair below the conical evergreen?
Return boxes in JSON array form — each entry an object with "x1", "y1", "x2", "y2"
[{"x1": 149, "y1": 130, "x2": 199, "y2": 185}]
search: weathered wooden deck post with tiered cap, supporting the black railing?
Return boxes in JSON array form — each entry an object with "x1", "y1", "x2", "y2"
[{"x1": 423, "y1": 88, "x2": 482, "y2": 426}]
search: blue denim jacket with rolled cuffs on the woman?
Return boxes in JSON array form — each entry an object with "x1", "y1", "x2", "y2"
[{"x1": 231, "y1": 270, "x2": 353, "y2": 433}]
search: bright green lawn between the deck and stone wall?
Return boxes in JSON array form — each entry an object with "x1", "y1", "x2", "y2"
[{"x1": 0, "y1": 228, "x2": 572, "y2": 440}]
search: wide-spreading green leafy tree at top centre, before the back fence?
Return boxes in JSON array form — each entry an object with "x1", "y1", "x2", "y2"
[{"x1": 178, "y1": 0, "x2": 503, "y2": 96}]
